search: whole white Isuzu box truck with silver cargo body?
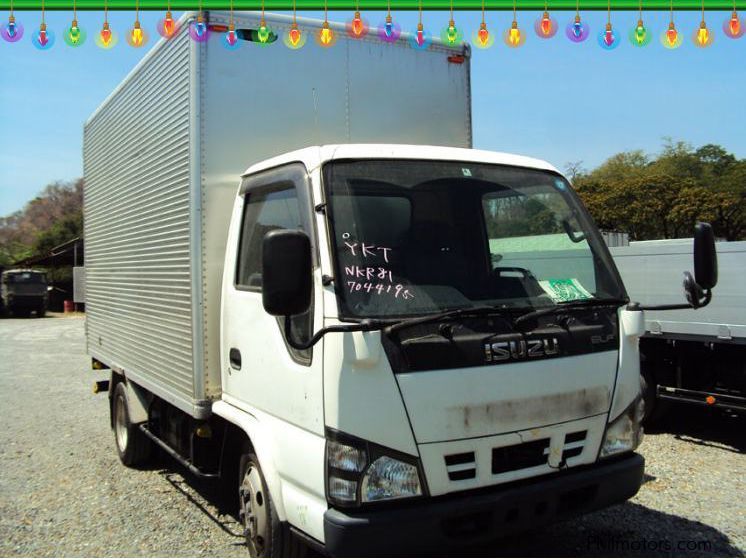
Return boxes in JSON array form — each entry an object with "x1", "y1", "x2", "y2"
[{"x1": 84, "y1": 12, "x2": 714, "y2": 556}]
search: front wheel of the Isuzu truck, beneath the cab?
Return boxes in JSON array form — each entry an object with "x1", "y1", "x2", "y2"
[{"x1": 238, "y1": 447, "x2": 307, "y2": 558}]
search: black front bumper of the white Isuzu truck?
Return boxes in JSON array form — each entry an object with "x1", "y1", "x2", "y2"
[{"x1": 324, "y1": 453, "x2": 645, "y2": 556}]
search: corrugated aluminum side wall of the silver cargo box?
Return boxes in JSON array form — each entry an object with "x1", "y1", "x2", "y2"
[{"x1": 83, "y1": 30, "x2": 204, "y2": 411}]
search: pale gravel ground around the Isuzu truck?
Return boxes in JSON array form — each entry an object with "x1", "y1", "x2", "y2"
[{"x1": 0, "y1": 317, "x2": 746, "y2": 557}]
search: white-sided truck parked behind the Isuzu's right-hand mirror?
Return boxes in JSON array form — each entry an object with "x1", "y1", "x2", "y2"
[{"x1": 611, "y1": 239, "x2": 746, "y2": 419}]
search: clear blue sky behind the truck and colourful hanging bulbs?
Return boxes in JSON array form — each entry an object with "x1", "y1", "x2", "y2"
[{"x1": 0, "y1": 8, "x2": 746, "y2": 216}]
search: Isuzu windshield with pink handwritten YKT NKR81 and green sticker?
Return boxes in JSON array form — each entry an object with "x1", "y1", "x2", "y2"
[{"x1": 324, "y1": 160, "x2": 625, "y2": 318}]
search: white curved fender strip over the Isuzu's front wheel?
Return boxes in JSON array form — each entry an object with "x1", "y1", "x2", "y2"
[{"x1": 212, "y1": 400, "x2": 287, "y2": 521}]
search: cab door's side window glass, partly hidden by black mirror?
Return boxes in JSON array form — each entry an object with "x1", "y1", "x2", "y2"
[{"x1": 236, "y1": 186, "x2": 303, "y2": 291}]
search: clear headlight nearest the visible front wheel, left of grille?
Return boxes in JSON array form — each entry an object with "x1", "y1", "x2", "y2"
[{"x1": 326, "y1": 432, "x2": 423, "y2": 507}]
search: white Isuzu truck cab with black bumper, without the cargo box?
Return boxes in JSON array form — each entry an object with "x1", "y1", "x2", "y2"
[{"x1": 217, "y1": 144, "x2": 644, "y2": 556}]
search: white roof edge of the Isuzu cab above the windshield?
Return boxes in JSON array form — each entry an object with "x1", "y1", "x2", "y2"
[{"x1": 244, "y1": 144, "x2": 559, "y2": 176}]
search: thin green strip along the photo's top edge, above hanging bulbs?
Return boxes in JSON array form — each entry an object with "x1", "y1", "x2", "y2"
[{"x1": 0, "y1": 0, "x2": 746, "y2": 11}]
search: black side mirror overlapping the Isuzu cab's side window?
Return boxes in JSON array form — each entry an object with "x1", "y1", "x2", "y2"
[{"x1": 262, "y1": 229, "x2": 311, "y2": 316}]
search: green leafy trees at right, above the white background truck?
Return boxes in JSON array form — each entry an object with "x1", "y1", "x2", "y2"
[{"x1": 574, "y1": 139, "x2": 746, "y2": 241}]
